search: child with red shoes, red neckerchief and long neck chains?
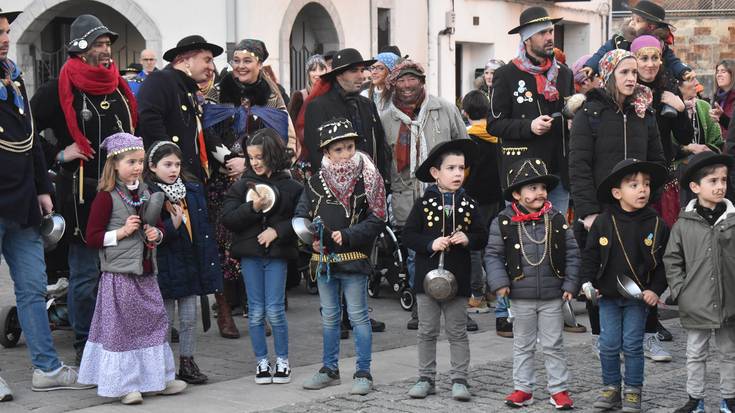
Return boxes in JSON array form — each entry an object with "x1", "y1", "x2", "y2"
[{"x1": 485, "y1": 158, "x2": 579, "y2": 410}]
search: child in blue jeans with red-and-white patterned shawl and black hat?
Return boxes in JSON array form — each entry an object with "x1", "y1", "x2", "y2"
[{"x1": 294, "y1": 118, "x2": 386, "y2": 395}]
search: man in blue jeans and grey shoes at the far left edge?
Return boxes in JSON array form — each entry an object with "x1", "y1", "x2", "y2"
[{"x1": 0, "y1": 10, "x2": 95, "y2": 402}]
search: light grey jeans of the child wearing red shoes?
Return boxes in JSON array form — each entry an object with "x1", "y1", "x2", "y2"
[{"x1": 513, "y1": 298, "x2": 569, "y2": 394}]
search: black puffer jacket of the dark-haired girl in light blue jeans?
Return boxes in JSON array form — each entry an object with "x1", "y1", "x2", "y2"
[{"x1": 222, "y1": 170, "x2": 303, "y2": 259}]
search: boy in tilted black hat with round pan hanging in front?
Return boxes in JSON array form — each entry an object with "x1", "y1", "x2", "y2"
[{"x1": 403, "y1": 139, "x2": 487, "y2": 401}]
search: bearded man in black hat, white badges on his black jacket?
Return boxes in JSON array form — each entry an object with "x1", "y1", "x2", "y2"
[{"x1": 487, "y1": 7, "x2": 574, "y2": 213}]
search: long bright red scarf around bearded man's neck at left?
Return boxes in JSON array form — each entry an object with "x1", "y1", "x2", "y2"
[{"x1": 59, "y1": 57, "x2": 138, "y2": 155}]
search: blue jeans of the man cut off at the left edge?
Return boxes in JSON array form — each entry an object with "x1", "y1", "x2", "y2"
[{"x1": 0, "y1": 218, "x2": 61, "y2": 372}]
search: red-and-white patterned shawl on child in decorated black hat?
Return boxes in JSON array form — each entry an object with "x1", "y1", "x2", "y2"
[{"x1": 319, "y1": 151, "x2": 386, "y2": 220}]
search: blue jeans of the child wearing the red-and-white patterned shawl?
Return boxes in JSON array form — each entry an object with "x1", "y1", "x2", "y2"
[{"x1": 317, "y1": 273, "x2": 373, "y2": 373}]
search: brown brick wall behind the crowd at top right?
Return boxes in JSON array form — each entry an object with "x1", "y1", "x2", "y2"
[{"x1": 613, "y1": 16, "x2": 735, "y2": 97}]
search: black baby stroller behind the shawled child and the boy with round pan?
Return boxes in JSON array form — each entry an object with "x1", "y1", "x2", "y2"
[{"x1": 368, "y1": 224, "x2": 416, "y2": 311}]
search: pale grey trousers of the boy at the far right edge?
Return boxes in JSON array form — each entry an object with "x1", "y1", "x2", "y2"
[{"x1": 687, "y1": 326, "x2": 735, "y2": 399}]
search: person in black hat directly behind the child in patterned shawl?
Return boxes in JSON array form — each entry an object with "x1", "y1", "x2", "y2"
[{"x1": 296, "y1": 49, "x2": 389, "y2": 181}]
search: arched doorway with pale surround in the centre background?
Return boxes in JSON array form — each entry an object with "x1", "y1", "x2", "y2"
[{"x1": 281, "y1": 0, "x2": 344, "y2": 91}]
